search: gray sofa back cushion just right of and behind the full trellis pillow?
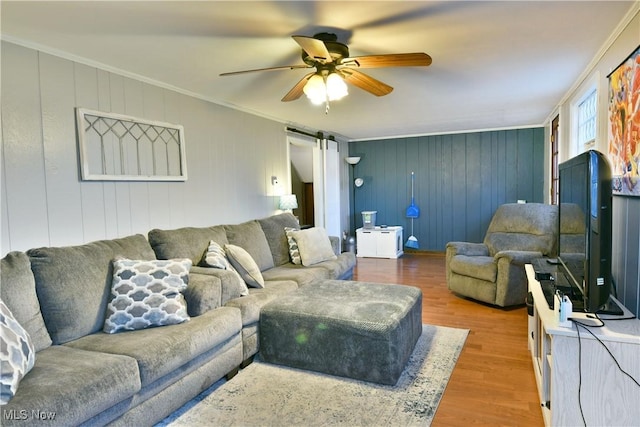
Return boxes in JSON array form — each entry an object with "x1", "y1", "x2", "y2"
[{"x1": 148, "y1": 225, "x2": 228, "y2": 265}]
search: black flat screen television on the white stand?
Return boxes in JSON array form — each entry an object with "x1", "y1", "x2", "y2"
[{"x1": 555, "y1": 150, "x2": 622, "y2": 314}]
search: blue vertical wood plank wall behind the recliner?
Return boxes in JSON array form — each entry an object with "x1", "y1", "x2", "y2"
[{"x1": 349, "y1": 128, "x2": 545, "y2": 251}]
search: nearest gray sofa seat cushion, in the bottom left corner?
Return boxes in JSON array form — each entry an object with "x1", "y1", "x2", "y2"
[{"x1": 2, "y1": 346, "x2": 140, "y2": 427}]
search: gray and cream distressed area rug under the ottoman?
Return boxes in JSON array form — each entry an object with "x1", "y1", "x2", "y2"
[{"x1": 157, "y1": 325, "x2": 469, "y2": 427}]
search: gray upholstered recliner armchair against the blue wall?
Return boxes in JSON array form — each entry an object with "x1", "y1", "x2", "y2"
[{"x1": 446, "y1": 203, "x2": 558, "y2": 307}]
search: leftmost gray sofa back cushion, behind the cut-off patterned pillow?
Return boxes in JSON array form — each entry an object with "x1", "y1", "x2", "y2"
[{"x1": 0, "y1": 252, "x2": 51, "y2": 351}]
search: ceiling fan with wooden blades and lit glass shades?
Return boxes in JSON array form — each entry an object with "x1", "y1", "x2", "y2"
[{"x1": 220, "y1": 33, "x2": 431, "y2": 109}]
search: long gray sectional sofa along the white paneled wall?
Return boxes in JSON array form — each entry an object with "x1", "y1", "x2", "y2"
[{"x1": 0, "y1": 213, "x2": 356, "y2": 426}]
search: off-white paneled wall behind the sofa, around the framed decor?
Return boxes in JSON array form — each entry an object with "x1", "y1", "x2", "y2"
[{"x1": 0, "y1": 42, "x2": 289, "y2": 255}]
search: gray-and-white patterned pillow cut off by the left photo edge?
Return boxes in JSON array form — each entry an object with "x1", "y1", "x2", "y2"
[{"x1": 0, "y1": 300, "x2": 36, "y2": 405}]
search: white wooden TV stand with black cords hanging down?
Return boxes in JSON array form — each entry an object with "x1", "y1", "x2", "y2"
[{"x1": 525, "y1": 264, "x2": 640, "y2": 426}]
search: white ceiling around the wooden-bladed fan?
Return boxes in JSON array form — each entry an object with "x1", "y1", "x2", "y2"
[{"x1": 0, "y1": 1, "x2": 633, "y2": 140}]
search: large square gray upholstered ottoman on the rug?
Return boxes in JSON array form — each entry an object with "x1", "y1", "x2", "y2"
[{"x1": 260, "y1": 280, "x2": 422, "y2": 384}]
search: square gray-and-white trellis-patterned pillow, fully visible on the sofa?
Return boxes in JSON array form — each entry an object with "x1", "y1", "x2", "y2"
[{"x1": 103, "y1": 258, "x2": 192, "y2": 334}]
